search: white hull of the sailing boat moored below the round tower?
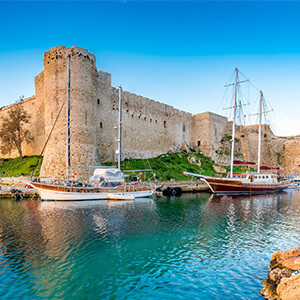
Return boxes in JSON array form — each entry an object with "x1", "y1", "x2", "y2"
[{"x1": 36, "y1": 188, "x2": 154, "y2": 201}]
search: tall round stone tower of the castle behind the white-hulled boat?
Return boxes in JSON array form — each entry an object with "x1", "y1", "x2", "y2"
[{"x1": 41, "y1": 46, "x2": 98, "y2": 179}]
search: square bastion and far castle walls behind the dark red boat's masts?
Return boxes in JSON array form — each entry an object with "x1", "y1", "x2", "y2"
[{"x1": 194, "y1": 112, "x2": 286, "y2": 168}]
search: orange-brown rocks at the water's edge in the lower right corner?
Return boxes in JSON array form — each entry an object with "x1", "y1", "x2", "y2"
[{"x1": 260, "y1": 246, "x2": 300, "y2": 300}]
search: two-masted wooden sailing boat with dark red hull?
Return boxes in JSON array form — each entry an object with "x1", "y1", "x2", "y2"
[{"x1": 184, "y1": 68, "x2": 291, "y2": 195}]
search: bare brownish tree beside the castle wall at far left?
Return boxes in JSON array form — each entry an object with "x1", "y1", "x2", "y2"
[{"x1": 0, "y1": 97, "x2": 33, "y2": 161}]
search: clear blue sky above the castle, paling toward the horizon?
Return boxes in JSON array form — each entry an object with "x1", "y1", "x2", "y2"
[{"x1": 0, "y1": 1, "x2": 300, "y2": 135}]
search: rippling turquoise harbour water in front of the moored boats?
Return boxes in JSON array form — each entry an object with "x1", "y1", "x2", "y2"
[{"x1": 0, "y1": 191, "x2": 300, "y2": 299}]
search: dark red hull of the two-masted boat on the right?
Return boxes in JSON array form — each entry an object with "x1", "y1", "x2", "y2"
[{"x1": 203, "y1": 178, "x2": 290, "y2": 195}]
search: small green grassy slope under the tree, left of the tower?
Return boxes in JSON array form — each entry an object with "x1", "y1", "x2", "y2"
[{"x1": 0, "y1": 156, "x2": 42, "y2": 177}]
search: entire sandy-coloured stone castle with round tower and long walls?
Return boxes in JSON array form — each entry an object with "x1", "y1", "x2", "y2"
[{"x1": 0, "y1": 46, "x2": 300, "y2": 177}]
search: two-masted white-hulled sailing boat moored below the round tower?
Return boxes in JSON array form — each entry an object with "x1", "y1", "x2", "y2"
[{"x1": 26, "y1": 56, "x2": 155, "y2": 201}]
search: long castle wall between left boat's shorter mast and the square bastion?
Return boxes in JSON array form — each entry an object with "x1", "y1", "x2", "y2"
[{"x1": 118, "y1": 92, "x2": 193, "y2": 158}]
